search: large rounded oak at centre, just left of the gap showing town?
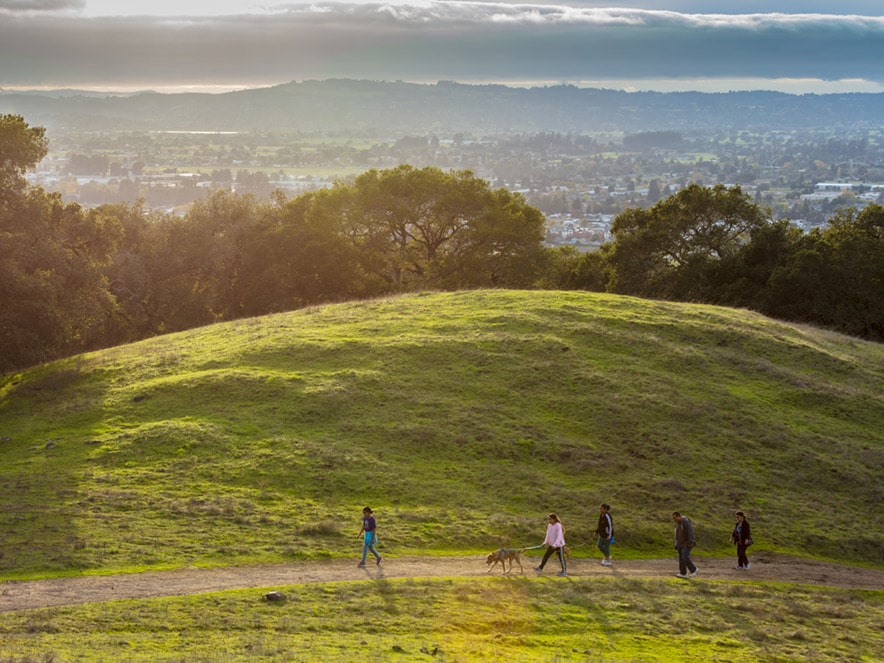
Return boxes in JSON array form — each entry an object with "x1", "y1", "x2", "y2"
[{"x1": 313, "y1": 165, "x2": 544, "y2": 291}]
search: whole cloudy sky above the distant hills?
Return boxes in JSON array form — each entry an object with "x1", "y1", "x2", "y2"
[{"x1": 0, "y1": 0, "x2": 884, "y2": 94}]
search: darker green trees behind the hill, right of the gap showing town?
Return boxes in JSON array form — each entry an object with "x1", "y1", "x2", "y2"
[{"x1": 558, "y1": 184, "x2": 884, "y2": 342}]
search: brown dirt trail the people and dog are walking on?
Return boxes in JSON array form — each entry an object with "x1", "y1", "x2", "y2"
[{"x1": 0, "y1": 554, "x2": 884, "y2": 612}]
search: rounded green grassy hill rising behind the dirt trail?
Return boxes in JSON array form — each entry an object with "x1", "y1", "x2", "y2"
[{"x1": 0, "y1": 291, "x2": 884, "y2": 578}]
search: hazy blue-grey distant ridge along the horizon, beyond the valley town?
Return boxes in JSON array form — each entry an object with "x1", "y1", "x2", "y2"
[{"x1": 0, "y1": 80, "x2": 884, "y2": 136}]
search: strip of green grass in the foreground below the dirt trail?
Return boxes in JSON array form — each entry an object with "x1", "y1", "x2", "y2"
[{"x1": 0, "y1": 578, "x2": 884, "y2": 663}]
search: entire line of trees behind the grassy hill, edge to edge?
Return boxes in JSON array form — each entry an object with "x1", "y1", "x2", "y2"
[{"x1": 0, "y1": 115, "x2": 884, "y2": 372}]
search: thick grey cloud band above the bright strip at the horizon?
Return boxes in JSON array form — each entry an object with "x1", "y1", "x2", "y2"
[{"x1": 0, "y1": 0, "x2": 884, "y2": 86}]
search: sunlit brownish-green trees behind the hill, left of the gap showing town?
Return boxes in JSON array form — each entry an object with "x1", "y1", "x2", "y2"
[{"x1": 0, "y1": 156, "x2": 544, "y2": 370}]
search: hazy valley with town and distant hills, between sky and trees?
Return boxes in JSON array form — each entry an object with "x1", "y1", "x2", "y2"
[{"x1": 0, "y1": 80, "x2": 884, "y2": 250}]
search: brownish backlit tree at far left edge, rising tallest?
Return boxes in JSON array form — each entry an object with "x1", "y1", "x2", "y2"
[{"x1": 0, "y1": 115, "x2": 118, "y2": 370}]
